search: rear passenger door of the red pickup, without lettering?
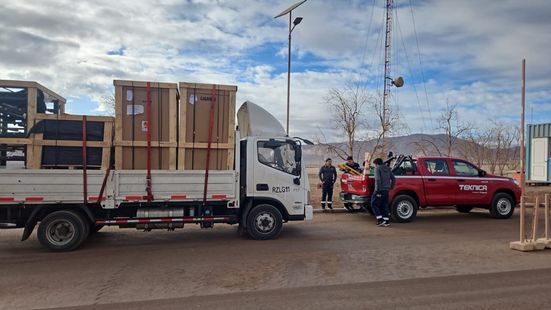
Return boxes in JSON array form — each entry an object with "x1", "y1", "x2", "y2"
[{"x1": 418, "y1": 158, "x2": 457, "y2": 206}]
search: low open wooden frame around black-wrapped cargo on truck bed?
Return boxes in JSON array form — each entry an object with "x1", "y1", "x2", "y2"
[{"x1": 0, "y1": 113, "x2": 114, "y2": 170}]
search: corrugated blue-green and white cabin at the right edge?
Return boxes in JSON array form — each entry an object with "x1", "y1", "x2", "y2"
[{"x1": 526, "y1": 123, "x2": 551, "y2": 183}]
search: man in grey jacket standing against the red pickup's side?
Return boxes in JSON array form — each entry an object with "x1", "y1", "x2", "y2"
[{"x1": 371, "y1": 158, "x2": 396, "y2": 227}]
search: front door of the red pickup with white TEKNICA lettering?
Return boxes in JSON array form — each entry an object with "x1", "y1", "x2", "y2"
[{"x1": 452, "y1": 160, "x2": 490, "y2": 205}]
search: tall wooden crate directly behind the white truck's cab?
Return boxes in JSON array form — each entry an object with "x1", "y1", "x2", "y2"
[{"x1": 178, "y1": 82, "x2": 237, "y2": 170}]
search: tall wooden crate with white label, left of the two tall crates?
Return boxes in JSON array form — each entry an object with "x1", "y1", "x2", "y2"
[{"x1": 113, "y1": 80, "x2": 178, "y2": 170}]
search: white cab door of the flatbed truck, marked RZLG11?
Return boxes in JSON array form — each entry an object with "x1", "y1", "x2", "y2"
[{"x1": 249, "y1": 139, "x2": 307, "y2": 214}]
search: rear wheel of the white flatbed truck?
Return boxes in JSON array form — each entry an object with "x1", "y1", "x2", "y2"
[{"x1": 37, "y1": 210, "x2": 90, "y2": 252}]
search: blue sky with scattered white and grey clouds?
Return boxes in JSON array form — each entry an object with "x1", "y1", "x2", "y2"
[{"x1": 0, "y1": 0, "x2": 551, "y2": 141}]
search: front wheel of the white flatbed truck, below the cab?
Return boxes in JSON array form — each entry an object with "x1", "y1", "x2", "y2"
[{"x1": 247, "y1": 204, "x2": 283, "y2": 240}]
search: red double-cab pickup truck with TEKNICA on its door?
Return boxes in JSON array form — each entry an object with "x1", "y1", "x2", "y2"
[{"x1": 340, "y1": 155, "x2": 521, "y2": 223}]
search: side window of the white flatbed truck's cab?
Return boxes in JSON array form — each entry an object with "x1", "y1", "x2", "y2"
[{"x1": 258, "y1": 141, "x2": 300, "y2": 175}]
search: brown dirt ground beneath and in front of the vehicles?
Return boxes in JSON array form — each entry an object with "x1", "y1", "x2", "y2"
[{"x1": 0, "y1": 209, "x2": 551, "y2": 309}]
